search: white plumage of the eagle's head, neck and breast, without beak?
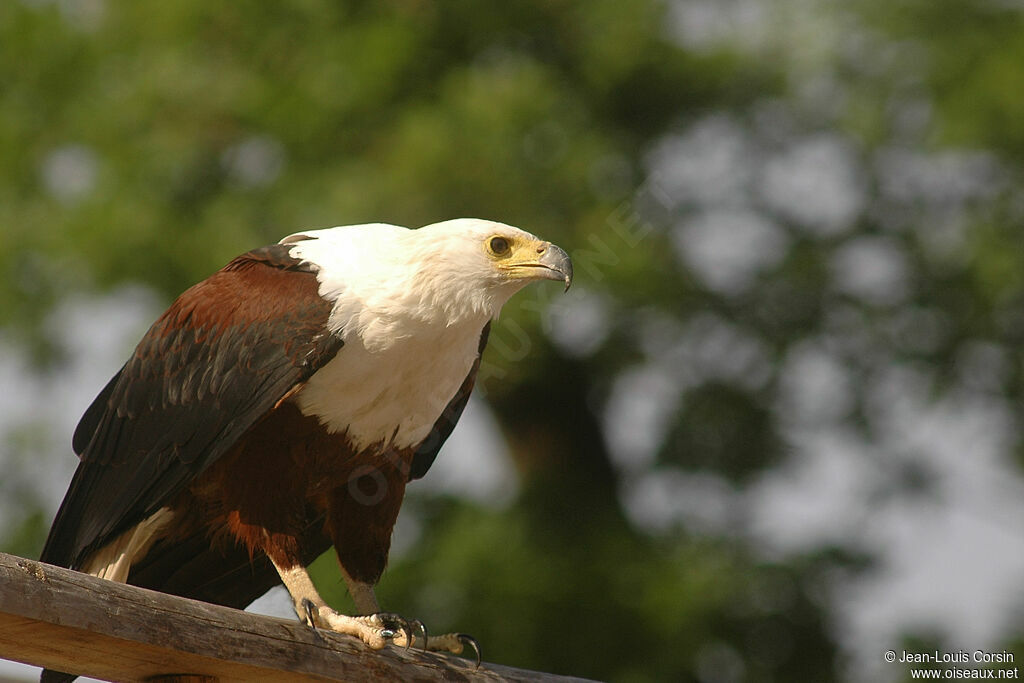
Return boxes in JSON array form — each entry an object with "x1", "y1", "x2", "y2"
[{"x1": 282, "y1": 218, "x2": 537, "y2": 449}]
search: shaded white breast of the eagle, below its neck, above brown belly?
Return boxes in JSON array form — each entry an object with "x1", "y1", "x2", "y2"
[{"x1": 296, "y1": 324, "x2": 482, "y2": 449}]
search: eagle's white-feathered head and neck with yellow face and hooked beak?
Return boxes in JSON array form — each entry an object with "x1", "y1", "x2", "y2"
[{"x1": 282, "y1": 218, "x2": 572, "y2": 328}]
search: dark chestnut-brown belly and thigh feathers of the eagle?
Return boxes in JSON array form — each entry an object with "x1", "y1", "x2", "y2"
[{"x1": 163, "y1": 402, "x2": 413, "y2": 583}]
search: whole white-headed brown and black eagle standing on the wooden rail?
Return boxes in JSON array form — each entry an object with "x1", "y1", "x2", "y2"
[{"x1": 41, "y1": 218, "x2": 572, "y2": 680}]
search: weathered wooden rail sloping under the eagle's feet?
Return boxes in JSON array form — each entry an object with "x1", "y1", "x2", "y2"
[{"x1": 0, "y1": 553, "x2": 583, "y2": 682}]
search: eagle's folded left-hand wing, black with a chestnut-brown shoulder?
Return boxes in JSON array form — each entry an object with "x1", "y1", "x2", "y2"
[{"x1": 42, "y1": 245, "x2": 342, "y2": 567}]
